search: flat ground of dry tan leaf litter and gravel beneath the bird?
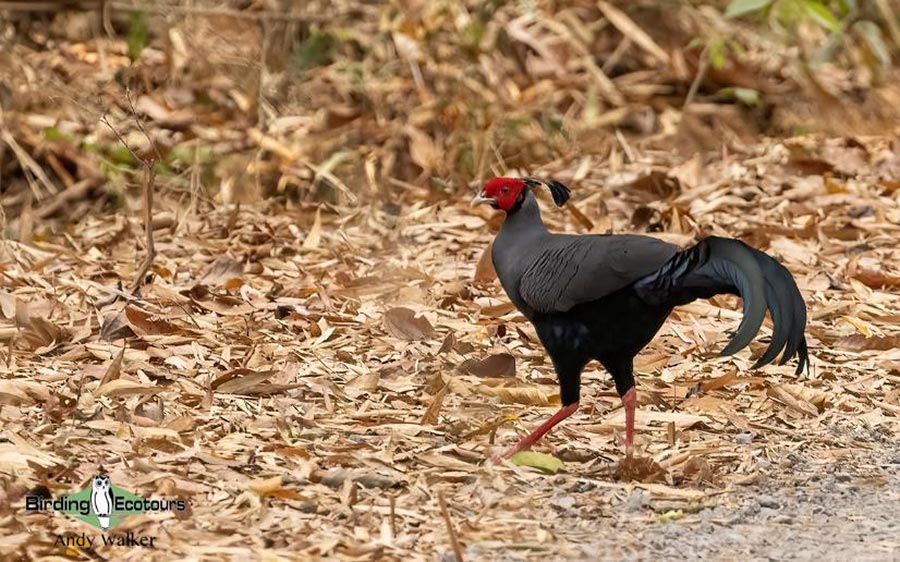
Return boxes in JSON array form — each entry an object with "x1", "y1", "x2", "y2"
[{"x1": 0, "y1": 133, "x2": 900, "y2": 560}]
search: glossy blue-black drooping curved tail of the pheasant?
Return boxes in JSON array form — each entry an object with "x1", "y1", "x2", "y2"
[{"x1": 634, "y1": 236, "x2": 809, "y2": 373}]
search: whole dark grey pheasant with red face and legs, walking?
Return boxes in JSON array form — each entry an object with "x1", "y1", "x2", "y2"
[{"x1": 472, "y1": 178, "x2": 809, "y2": 458}]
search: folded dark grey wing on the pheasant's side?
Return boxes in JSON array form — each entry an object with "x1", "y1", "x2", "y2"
[{"x1": 519, "y1": 234, "x2": 678, "y2": 313}]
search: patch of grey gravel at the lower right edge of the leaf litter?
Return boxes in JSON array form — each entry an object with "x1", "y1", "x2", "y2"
[{"x1": 620, "y1": 428, "x2": 900, "y2": 561}]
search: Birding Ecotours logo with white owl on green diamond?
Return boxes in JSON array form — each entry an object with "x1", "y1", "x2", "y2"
[{"x1": 25, "y1": 474, "x2": 187, "y2": 533}]
